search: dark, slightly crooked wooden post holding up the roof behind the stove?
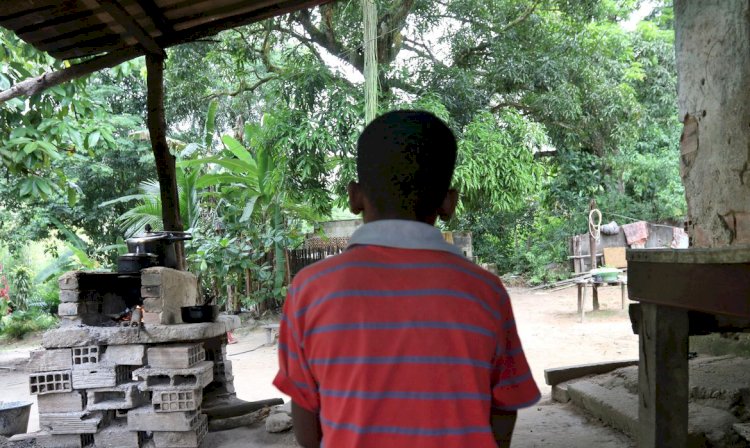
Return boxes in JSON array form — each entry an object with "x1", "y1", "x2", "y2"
[{"x1": 146, "y1": 55, "x2": 185, "y2": 270}]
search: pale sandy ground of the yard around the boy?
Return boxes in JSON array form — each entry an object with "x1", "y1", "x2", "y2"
[{"x1": 0, "y1": 288, "x2": 638, "y2": 448}]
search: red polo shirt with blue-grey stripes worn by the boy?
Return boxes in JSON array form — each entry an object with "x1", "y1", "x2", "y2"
[{"x1": 274, "y1": 220, "x2": 539, "y2": 448}]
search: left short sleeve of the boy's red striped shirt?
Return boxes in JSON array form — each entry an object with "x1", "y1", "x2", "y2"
[{"x1": 273, "y1": 292, "x2": 320, "y2": 413}]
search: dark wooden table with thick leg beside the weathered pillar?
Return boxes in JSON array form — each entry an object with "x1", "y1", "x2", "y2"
[{"x1": 627, "y1": 246, "x2": 750, "y2": 448}]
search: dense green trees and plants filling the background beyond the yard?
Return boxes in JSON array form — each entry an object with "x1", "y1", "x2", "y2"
[{"x1": 0, "y1": 0, "x2": 685, "y2": 316}]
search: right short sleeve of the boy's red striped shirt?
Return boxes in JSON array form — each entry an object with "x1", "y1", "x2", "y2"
[{"x1": 492, "y1": 293, "x2": 541, "y2": 411}]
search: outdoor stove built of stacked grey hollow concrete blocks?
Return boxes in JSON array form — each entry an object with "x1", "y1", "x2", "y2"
[{"x1": 28, "y1": 268, "x2": 239, "y2": 448}]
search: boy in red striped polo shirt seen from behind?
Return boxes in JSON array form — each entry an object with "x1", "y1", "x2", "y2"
[{"x1": 274, "y1": 111, "x2": 539, "y2": 448}]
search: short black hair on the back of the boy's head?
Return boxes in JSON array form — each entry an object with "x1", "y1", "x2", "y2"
[{"x1": 357, "y1": 110, "x2": 457, "y2": 219}]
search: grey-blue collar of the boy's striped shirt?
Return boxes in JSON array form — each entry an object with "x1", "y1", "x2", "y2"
[{"x1": 349, "y1": 219, "x2": 463, "y2": 257}]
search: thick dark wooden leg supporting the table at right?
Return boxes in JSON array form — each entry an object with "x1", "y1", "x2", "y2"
[{"x1": 638, "y1": 303, "x2": 688, "y2": 448}]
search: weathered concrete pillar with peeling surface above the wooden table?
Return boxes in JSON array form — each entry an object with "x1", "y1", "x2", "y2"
[{"x1": 675, "y1": 0, "x2": 750, "y2": 247}]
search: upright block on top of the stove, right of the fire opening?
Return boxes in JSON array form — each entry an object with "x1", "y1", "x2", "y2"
[{"x1": 141, "y1": 267, "x2": 198, "y2": 324}]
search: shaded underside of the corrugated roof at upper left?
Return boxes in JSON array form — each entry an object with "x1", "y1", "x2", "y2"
[{"x1": 0, "y1": 0, "x2": 329, "y2": 59}]
